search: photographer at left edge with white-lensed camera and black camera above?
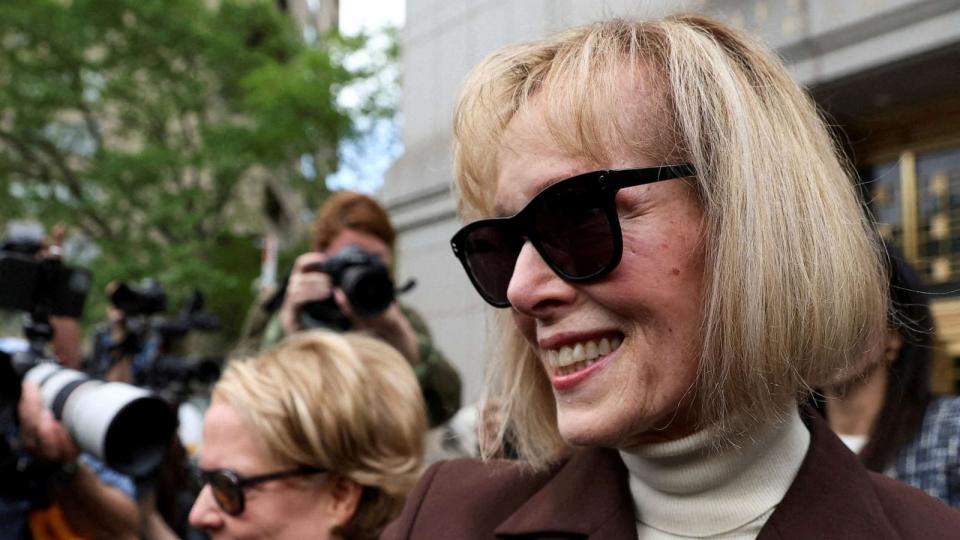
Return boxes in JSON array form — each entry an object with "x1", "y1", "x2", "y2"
[{"x1": 0, "y1": 224, "x2": 174, "y2": 539}]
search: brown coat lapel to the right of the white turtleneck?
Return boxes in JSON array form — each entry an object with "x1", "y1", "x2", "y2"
[{"x1": 757, "y1": 411, "x2": 899, "y2": 540}]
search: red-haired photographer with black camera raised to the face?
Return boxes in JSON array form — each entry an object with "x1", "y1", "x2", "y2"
[{"x1": 253, "y1": 191, "x2": 460, "y2": 427}]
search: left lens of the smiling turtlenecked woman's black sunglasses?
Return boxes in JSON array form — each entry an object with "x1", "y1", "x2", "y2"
[{"x1": 463, "y1": 224, "x2": 523, "y2": 303}]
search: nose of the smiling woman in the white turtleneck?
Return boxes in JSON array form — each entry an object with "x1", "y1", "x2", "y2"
[{"x1": 507, "y1": 241, "x2": 576, "y2": 318}]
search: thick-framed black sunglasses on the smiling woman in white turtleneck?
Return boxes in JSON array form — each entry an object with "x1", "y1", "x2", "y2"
[{"x1": 450, "y1": 164, "x2": 696, "y2": 307}]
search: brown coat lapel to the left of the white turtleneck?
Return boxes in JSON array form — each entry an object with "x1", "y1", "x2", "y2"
[{"x1": 494, "y1": 449, "x2": 637, "y2": 540}]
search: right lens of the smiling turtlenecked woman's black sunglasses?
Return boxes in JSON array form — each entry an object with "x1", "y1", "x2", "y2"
[{"x1": 533, "y1": 184, "x2": 616, "y2": 278}]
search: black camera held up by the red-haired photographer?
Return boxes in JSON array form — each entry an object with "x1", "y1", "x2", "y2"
[{"x1": 302, "y1": 244, "x2": 396, "y2": 330}]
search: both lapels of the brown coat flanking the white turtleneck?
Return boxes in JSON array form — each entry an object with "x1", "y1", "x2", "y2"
[{"x1": 494, "y1": 410, "x2": 898, "y2": 540}]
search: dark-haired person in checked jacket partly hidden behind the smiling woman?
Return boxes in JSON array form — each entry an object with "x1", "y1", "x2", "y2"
[{"x1": 821, "y1": 244, "x2": 960, "y2": 508}]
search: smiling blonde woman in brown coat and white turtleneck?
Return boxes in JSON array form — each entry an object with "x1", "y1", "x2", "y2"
[{"x1": 383, "y1": 14, "x2": 960, "y2": 540}]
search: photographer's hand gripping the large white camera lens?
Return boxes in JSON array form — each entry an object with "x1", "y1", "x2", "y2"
[{"x1": 17, "y1": 383, "x2": 80, "y2": 463}]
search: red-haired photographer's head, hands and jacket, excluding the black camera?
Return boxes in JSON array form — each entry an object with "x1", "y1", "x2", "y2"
[{"x1": 245, "y1": 191, "x2": 461, "y2": 428}]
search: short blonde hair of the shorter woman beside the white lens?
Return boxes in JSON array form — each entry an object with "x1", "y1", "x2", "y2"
[{"x1": 219, "y1": 331, "x2": 427, "y2": 539}]
